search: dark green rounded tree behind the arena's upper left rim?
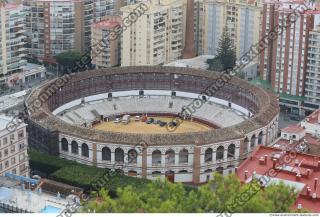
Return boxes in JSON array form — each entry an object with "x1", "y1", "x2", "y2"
[{"x1": 55, "y1": 51, "x2": 81, "y2": 74}]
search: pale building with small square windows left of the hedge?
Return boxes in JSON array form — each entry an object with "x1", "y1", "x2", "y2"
[{"x1": 0, "y1": 114, "x2": 29, "y2": 177}]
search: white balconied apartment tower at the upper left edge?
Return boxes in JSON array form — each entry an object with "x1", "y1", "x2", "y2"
[{"x1": 0, "y1": 4, "x2": 26, "y2": 84}]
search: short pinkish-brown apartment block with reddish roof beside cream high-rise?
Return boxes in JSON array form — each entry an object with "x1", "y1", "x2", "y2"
[{"x1": 91, "y1": 16, "x2": 121, "y2": 69}]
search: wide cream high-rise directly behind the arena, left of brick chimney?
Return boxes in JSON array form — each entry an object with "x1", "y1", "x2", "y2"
[{"x1": 121, "y1": 0, "x2": 186, "y2": 66}]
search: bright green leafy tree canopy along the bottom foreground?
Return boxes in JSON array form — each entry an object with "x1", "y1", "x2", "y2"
[{"x1": 83, "y1": 174, "x2": 297, "y2": 213}]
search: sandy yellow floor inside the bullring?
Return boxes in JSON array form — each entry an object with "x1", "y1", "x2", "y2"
[{"x1": 94, "y1": 117, "x2": 212, "y2": 134}]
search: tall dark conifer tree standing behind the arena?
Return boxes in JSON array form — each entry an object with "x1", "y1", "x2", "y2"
[{"x1": 207, "y1": 28, "x2": 236, "y2": 72}]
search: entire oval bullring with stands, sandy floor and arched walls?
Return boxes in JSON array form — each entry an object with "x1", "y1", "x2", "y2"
[{"x1": 26, "y1": 66, "x2": 279, "y2": 184}]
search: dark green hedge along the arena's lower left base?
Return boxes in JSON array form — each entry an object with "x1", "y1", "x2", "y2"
[{"x1": 28, "y1": 149, "x2": 150, "y2": 192}]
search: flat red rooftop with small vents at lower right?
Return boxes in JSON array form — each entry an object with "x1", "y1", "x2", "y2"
[{"x1": 236, "y1": 146, "x2": 320, "y2": 212}]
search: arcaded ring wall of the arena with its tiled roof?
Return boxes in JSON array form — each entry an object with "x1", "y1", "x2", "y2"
[{"x1": 26, "y1": 66, "x2": 279, "y2": 184}]
